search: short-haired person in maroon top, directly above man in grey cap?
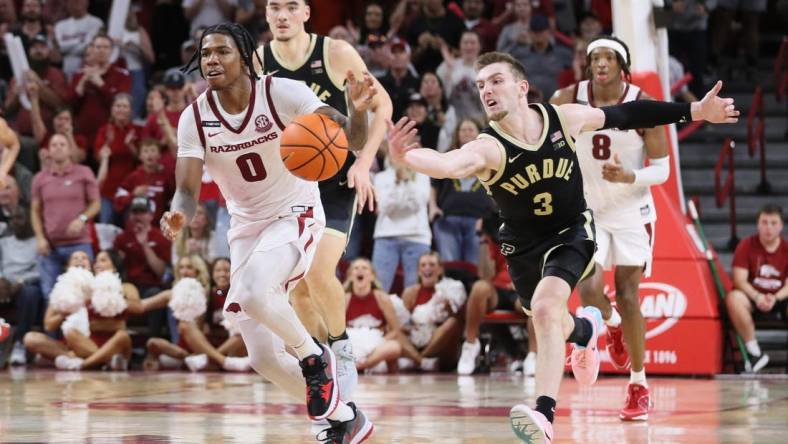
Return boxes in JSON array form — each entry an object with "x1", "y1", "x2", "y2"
[{"x1": 113, "y1": 139, "x2": 175, "y2": 226}]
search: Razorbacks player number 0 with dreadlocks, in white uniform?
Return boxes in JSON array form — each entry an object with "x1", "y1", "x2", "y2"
[{"x1": 161, "y1": 23, "x2": 376, "y2": 444}]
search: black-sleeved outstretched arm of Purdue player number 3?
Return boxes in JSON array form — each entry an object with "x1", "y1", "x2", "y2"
[{"x1": 559, "y1": 81, "x2": 739, "y2": 137}]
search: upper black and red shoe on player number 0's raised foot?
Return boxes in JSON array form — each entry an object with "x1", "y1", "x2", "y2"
[{"x1": 299, "y1": 341, "x2": 339, "y2": 420}]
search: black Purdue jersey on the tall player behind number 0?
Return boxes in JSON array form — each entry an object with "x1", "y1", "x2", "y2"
[{"x1": 263, "y1": 34, "x2": 353, "y2": 191}]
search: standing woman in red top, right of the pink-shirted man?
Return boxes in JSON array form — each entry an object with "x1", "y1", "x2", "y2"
[{"x1": 94, "y1": 93, "x2": 141, "y2": 226}]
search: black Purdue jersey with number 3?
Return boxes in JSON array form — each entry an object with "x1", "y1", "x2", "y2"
[{"x1": 479, "y1": 104, "x2": 586, "y2": 234}]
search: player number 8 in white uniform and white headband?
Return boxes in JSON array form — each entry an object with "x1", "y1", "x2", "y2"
[{"x1": 551, "y1": 36, "x2": 670, "y2": 421}]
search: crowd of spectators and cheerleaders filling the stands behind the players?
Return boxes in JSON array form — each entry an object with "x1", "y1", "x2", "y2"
[{"x1": 0, "y1": 0, "x2": 780, "y2": 373}]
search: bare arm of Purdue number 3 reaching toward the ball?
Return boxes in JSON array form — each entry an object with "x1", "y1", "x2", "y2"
[{"x1": 388, "y1": 117, "x2": 500, "y2": 179}]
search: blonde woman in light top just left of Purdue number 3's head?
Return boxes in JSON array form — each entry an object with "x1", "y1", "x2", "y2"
[{"x1": 438, "y1": 31, "x2": 485, "y2": 125}]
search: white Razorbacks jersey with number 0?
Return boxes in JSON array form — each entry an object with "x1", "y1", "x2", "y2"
[{"x1": 178, "y1": 76, "x2": 324, "y2": 240}]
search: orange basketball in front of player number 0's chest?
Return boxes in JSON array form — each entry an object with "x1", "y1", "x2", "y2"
[{"x1": 280, "y1": 114, "x2": 348, "y2": 181}]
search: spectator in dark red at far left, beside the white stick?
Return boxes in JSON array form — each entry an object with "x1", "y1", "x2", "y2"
[{"x1": 5, "y1": 34, "x2": 68, "y2": 136}]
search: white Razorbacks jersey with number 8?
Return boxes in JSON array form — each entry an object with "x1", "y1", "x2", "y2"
[{"x1": 575, "y1": 80, "x2": 656, "y2": 225}]
